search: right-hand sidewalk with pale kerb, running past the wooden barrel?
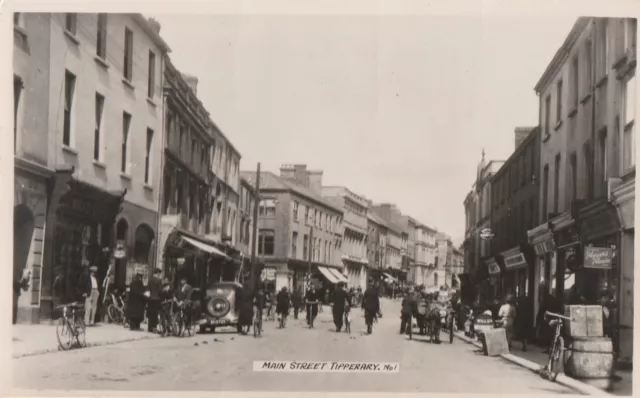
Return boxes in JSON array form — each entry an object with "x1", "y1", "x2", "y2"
[{"x1": 455, "y1": 332, "x2": 633, "y2": 396}]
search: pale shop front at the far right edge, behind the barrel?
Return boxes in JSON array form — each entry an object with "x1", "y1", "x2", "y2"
[{"x1": 611, "y1": 178, "x2": 636, "y2": 367}]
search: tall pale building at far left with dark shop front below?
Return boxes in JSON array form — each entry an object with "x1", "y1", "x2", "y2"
[{"x1": 14, "y1": 13, "x2": 169, "y2": 322}]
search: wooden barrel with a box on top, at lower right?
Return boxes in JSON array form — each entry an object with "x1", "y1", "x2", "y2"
[{"x1": 564, "y1": 337, "x2": 615, "y2": 389}]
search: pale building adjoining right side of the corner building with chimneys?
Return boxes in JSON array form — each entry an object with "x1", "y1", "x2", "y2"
[{"x1": 319, "y1": 185, "x2": 369, "y2": 291}]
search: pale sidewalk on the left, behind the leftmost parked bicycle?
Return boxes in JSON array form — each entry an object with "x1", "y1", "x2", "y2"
[{"x1": 11, "y1": 324, "x2": 158, "y2": 358}]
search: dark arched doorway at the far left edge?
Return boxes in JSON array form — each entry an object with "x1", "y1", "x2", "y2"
[{"x1": 13, "y1": 205, "x2": 35, "y2": 323}]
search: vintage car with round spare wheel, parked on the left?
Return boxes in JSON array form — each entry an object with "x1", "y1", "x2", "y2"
[{"x1": 198, "y1": 282, "x2": 242, "y2": 333}]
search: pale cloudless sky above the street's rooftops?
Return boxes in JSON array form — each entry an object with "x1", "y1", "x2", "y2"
[{"x1": 147, "y1": 14, "x2": 575, "y2": 243}]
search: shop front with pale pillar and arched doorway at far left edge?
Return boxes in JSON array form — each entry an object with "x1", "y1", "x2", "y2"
[{"x1": 13, "y1": 158, "x2": 52, "y2": 323}]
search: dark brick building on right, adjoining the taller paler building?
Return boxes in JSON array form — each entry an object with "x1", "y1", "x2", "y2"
[{"x1": 489, "y1": 127, "x2": 540, "y2": 318}]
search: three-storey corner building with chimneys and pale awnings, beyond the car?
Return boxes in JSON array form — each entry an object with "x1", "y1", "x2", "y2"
[{"x1": 241, "y1": 165, "x2": 348, "y2": 291}]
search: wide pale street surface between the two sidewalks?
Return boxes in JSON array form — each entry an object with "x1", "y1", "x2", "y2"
[{"x1": 13, "y1": 301, "x2": 572, "y2": 394}]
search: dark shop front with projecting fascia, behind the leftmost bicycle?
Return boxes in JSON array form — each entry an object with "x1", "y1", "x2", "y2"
[{"x1": 40, "y1": 168, "x2": 126, "y2": 318}]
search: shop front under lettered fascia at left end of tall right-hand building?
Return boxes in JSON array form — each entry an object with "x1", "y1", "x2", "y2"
[{"x1": 527, "y1": 223, "x2": 556, "y2": 326}]
